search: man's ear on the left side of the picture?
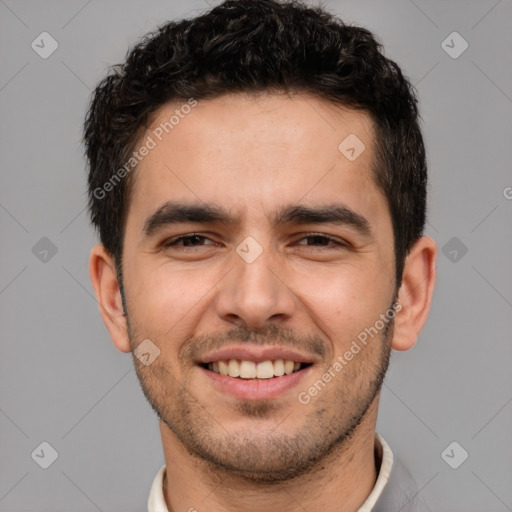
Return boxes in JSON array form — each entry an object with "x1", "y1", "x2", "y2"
[{"x1": 89, "y1": 244, "x2": 131, "y2": 352}]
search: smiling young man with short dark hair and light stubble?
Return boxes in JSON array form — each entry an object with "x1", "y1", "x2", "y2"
[{"x1": 85, "y1": 0, "x2": 436, "y2": 512}]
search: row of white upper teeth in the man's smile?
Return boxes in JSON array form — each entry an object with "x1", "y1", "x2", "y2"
[{"x1": 208, "y1": 359, "x2": 300, "y2": 379}]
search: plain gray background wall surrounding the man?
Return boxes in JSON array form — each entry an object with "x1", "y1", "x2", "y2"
[{"x1": 0, "y1": 0, "x2": 512, "y2": 512}]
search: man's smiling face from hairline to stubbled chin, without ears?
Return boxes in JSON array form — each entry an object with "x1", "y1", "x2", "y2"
[{"x1": 123, "y1": 94, "x2": 395, "y2": 480}]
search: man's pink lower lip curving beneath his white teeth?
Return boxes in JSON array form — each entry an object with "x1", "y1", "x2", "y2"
[{"x1": 199, "y1": 366, "x2": 313, "y2": 400}]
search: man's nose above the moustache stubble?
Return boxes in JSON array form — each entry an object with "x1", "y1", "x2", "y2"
[{"x1": 215, "y1": 242, "x2": 296, "y2": 329}]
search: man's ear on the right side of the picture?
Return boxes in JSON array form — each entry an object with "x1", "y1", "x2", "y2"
[{"x1": 391, "y1": 236, "x2": 437, "y2": 350}]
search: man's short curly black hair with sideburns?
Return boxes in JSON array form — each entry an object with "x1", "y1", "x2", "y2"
[{"x1": 84, "y1": 0, "x2": 427, "y2": 286}]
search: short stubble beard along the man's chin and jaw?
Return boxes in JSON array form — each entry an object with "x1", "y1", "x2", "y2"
[{"x1": 127, "y1": 317, "x2": 393, "y2": 484}]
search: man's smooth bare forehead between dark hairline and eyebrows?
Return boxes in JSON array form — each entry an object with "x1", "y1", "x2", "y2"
[{"x1": 128, "y1": 93, "x2": 386, "y2": 233}]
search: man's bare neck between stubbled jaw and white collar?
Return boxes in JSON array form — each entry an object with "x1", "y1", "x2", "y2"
[{"x1": 160, "y1": 396, "x2": 378, "y2": 512}]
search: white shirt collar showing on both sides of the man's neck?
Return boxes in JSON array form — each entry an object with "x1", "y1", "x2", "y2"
[{"x1": 148, "y1": 434, "x2": 393, "y2": 512}]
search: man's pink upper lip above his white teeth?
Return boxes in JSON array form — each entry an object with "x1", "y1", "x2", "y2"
[{"x1": 198, "y1": 346, "x2": 317, "y2": 364}]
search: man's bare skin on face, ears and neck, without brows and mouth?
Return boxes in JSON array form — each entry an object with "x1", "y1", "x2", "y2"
[{"x1": 90, "y1": 93, "x2": 437, "y2": 512}]
